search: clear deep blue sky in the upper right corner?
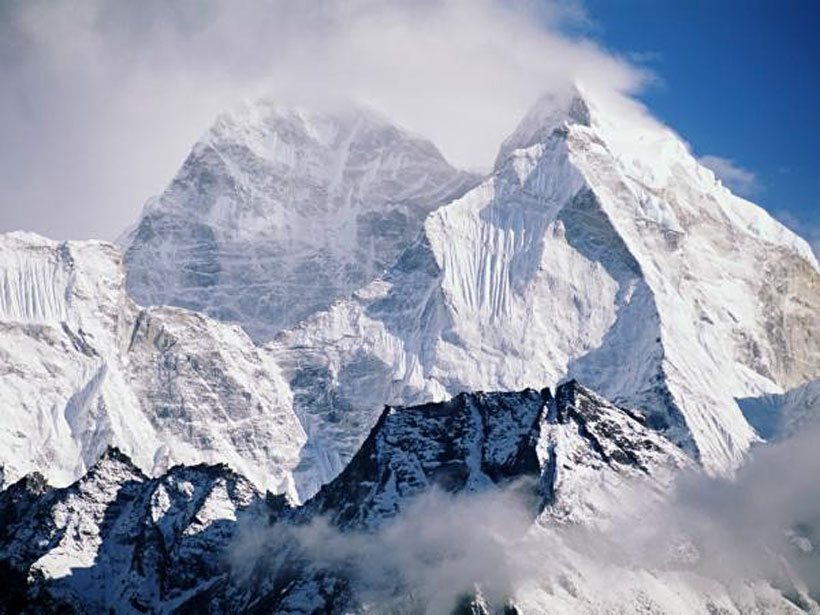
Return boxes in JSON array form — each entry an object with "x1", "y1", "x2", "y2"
[{"x1": 583, "y1": 0, "x2": 820, "y2": 252}]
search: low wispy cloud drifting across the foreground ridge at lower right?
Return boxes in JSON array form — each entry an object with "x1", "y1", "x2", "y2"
[{"x1": 229, "y1": 428, "x2": 820, "y2": 614}]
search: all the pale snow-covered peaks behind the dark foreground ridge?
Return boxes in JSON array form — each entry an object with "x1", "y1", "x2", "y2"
[{"x1": 0, "y1": 90, "x2": 820, "y2": 500}]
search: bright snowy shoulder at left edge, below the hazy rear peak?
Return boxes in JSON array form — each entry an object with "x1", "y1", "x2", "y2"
[{"x1": 0, "y1": 233, "x2": 305, "y2": 492}]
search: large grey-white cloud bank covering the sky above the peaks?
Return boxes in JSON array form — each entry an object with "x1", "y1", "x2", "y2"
[{"x1": 0, "y1": 0, "x2": 644, "y2": 243}]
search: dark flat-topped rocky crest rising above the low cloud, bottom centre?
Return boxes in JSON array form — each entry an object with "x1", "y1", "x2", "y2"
[{"x1": 304, "y1": 381, "x2": 692, "y2": 530}]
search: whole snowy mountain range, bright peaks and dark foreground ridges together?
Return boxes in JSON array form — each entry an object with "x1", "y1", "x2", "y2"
[{"x1": 0, "y1": 76, "x2": 820, "y2": 615}]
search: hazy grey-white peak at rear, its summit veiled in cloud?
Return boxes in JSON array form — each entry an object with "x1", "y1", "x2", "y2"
[{"x1": 124, "y1": 102, "x2": 477, "y2": 340}]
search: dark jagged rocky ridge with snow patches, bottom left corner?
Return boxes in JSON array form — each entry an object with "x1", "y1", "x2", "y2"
[{"x1": 0, "y1": 448, "x2": 268, "y2": 614}]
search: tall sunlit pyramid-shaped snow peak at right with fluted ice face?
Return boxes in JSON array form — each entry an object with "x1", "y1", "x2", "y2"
[{"x1": 269, "y1": 86, "x2": 820, "y2": 494}]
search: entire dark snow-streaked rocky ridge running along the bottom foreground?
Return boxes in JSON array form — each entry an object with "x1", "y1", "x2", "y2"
[{"x1": 0, "y1": 382, "x2": 817, "y2": 615}]
